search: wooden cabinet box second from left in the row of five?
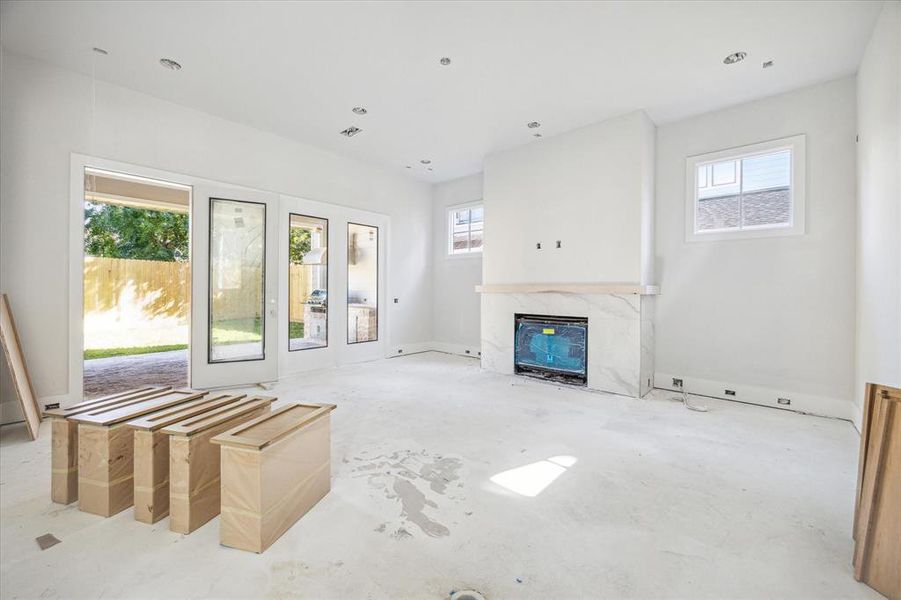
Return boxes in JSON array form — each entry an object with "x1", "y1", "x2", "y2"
[{"x1": 69, "y1": 390, "x2": 206, "y2": 517}]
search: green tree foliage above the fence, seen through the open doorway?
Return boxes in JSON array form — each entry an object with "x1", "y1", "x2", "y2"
[{"x1": 84, "y1": 202, "x2": 189, "y2": 262}]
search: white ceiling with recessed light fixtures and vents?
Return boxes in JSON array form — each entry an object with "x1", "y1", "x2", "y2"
[{"x1": 0, "y1": 1, "x2": 882, "y2": 181}]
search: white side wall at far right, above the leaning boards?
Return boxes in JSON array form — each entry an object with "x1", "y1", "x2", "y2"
[{"x1": 854, "y1": 2, "x2": 901, "y2": 421}]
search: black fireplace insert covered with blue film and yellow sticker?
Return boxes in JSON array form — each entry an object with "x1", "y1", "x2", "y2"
[{"x1": 513, "y1": 314, "x2": 588, "y2": 385}]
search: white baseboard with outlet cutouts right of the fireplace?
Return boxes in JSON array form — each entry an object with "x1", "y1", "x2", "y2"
[{"x1": 654, "y1": 372, "x2": 854, "y2": 423}]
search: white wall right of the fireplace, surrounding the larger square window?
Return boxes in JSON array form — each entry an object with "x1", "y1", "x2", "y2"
[{"x1": 655, "y1": 78, "x2": 856, "y2": 418}]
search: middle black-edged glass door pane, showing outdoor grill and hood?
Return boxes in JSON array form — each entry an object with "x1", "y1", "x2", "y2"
[{"x1": 288, "y1": 213, "x2": 328, "y2": 352}]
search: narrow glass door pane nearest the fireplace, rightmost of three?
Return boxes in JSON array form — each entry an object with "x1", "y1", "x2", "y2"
[{"x1": 347, "y1": 223, "x2": 379, "y2": 344}]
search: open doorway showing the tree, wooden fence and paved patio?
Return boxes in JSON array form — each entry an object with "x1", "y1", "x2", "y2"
[{"x1": 82, "y1": 169, "x2": 191, "y2": 398}]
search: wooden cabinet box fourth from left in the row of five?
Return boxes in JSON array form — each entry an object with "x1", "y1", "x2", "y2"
[{"x1": 163, "y1": 396, "x2": 275, "y2": 534}]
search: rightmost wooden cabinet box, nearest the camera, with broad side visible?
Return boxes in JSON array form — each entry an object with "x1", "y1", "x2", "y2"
[{"x1": 212, "y1": 404, "x2": 335, "y2": 552}]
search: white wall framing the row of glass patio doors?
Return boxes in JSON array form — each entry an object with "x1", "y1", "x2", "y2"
[{"x1": 0, "y1": 52, "x2": 432, "y2": 417}]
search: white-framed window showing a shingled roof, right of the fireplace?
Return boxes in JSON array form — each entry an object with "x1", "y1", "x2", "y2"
[{"x1": 685, "y1": 135, "x2": 805, "y2": 241}]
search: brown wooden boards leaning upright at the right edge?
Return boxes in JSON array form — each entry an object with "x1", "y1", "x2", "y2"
[{"x1": 854, "y1": 385, "x2": 901, "y2": 599}]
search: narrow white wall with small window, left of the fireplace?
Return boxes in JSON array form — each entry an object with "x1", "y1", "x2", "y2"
[{"x1": 432, "y1": 173, "x2": 482, "y2": 355}]
